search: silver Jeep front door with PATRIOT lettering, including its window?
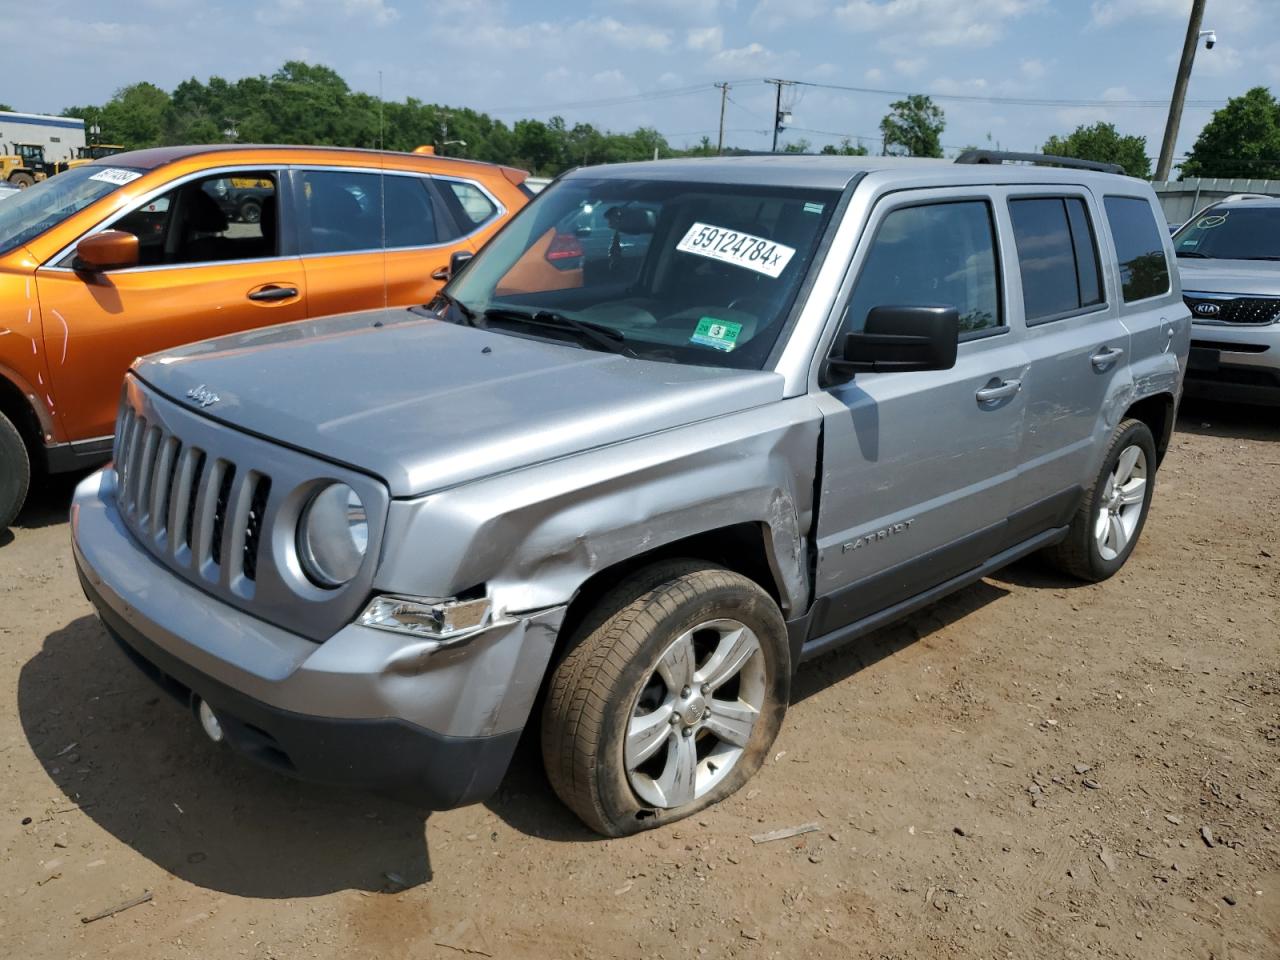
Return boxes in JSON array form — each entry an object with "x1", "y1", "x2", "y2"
[{"x1": 812, "y1": 191, "x2": 1027, "y2": 636}]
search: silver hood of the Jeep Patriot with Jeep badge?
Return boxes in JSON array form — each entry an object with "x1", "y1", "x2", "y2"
[{"x1": 134, "y1": 310, "x2": 782, "y2": 497}]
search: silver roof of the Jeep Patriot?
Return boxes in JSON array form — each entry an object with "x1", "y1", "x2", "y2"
[{"x1": 567, "y1": 154, "x2": 1146, "y2": 189}]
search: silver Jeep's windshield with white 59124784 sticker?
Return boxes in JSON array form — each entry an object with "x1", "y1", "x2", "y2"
[{"x1": 433, "y1": 178, "x2": 840, "y2": 369}]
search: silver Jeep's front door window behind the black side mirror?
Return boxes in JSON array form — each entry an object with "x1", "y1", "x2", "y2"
[{"x1": 842, "y1": 200, "x2": 1004, "y2": 333}]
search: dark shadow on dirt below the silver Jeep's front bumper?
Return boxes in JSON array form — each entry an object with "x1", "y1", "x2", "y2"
[{"x1": 18, "y1": 617, "x2": 431, "y2": 899}]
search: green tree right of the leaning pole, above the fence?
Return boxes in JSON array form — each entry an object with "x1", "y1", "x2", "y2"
[{"x1": 1181, "y1": 87, "x2": 1280, "y2": 179}]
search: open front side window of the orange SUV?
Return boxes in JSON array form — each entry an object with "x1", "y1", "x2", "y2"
[{"x1": 111, "y1": 170, "x2": 279, "y2": 266}]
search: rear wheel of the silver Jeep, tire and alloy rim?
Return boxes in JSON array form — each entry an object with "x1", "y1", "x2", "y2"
[{"x1": 1044, "y1": 420, "x2": 1156, "y2": 584}]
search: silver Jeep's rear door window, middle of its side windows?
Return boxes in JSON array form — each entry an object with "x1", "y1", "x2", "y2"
[{"x1": 1009, "y1": 197, "x2": 1102, "y2": 325}]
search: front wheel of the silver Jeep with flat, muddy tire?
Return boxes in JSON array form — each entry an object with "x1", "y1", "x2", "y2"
[{"x1": 541, "y1": 561, "x2": 791, "y2": 837}]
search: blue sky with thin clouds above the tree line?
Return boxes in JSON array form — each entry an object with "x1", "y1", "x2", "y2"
[{"x1": 10, "y1": 0, "x2": 1280, "y2": 168}]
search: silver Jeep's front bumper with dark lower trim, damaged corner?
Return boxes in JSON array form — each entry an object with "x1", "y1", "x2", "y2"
[{"x1": 72, "y1": 468, "x2": 564, "y2": 809}]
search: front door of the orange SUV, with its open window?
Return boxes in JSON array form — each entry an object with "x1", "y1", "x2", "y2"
[{"x1": 36, "y1": 170, "x2": 306, "y2": 440}]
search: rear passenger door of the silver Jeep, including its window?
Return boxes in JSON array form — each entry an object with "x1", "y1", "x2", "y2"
[{"x1": 1005, "y1": 187, "x2": 1130, "y2": 519}]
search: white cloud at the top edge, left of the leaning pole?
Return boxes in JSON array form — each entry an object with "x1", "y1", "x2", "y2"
[{"x1": 835, "y1": 0, "x2": 1044, "y2": 50}]
